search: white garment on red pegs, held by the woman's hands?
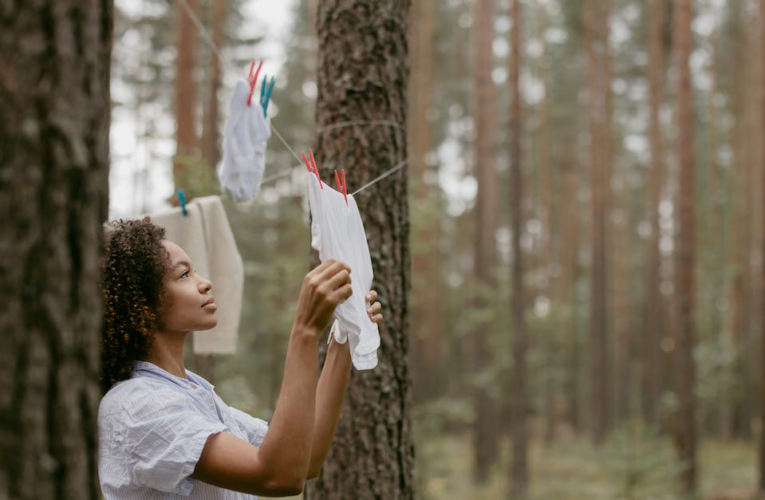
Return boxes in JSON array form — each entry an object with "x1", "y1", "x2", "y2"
[{"x1": 308, "y1": 178, "x2": 380, "y2": 370}]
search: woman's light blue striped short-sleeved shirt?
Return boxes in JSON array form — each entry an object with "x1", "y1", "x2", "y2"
[{"x1": 98, "y1": 361, "x2": 268, "y2": 500}]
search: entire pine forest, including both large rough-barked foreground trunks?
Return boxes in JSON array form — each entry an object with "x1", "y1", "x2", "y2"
[{"x1": 0, "y1": 0, "x2": 765, "y2": 500}]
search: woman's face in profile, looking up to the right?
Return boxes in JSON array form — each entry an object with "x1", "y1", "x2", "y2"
[{"x1": 162, "y1": 240, "x2": 218, "y2": 332}]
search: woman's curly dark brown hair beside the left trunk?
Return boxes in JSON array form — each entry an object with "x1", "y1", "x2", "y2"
[{"x1": 101, "y1": 217, "x2": 170, "y2": 394}]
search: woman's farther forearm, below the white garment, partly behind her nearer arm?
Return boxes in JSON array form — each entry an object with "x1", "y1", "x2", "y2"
[{"x1": 308, "y1": 332, "x2": 351, "y2": 478}]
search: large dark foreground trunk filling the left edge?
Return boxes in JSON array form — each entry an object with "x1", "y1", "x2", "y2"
[{"x1": 0, "y1": 0, "x2": 113, "y2": 500}]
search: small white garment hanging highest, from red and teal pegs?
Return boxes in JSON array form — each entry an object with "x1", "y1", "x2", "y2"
[{"x1": 218, "y1": 80, "x2": 271, "y2": 202}]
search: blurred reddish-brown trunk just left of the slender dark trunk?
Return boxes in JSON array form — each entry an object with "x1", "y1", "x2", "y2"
[{"x1": 473, "y1": 0, "x2": 499, "y2": 484}]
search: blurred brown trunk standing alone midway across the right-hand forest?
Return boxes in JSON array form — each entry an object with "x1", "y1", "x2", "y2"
[{"x1": 584, "y1": 0, "x2": 609, "y2": 444}]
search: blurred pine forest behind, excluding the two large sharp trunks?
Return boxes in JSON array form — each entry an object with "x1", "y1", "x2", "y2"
[{"x1": 110, "y1": 0, "x2": 765, "y2": 499}]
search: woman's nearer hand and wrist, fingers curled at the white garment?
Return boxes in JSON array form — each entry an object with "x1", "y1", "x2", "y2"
[{"x1": 295, "y1": 259, "x2": 352, "y2": 340}]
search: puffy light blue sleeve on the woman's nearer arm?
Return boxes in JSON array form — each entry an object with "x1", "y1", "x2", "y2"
[{"x1": 123, "y1": 390, "x2": 226, "y2": 496}]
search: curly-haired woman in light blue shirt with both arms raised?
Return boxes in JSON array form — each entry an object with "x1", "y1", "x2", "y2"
[{"x1": 98, "y1": 218, "x2": 382, "y2": 500}]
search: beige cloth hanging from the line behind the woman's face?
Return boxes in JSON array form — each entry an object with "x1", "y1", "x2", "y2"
[{"x1": 150, "y1": 196, "x2": 244, "y2": 354}]
